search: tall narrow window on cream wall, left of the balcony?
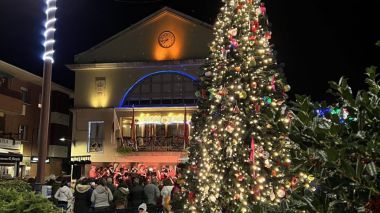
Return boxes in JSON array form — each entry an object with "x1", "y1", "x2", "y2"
[{"x1": 88, "y1": 121, "x2": 104, "y2": 152}]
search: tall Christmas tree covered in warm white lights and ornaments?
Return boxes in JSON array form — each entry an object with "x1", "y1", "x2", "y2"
[{"x1": 185, "y1": 0, "x2": 310, "y2": 212}]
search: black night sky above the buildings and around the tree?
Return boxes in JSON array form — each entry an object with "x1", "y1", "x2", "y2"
[{"x1": 0, "y1": 0, "x2": 380, "y2": 100}]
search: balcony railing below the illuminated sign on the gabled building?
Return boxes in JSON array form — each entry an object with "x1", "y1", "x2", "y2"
[{"x1": 122, "y1": 136, "x2": 187, "y2": 152}]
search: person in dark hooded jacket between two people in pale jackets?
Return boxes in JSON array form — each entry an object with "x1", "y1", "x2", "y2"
[{"x1": 74, "y1": 181, "x2": 93, "y2": 213}]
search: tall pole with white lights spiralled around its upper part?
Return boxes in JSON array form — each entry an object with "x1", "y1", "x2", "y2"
[{"x1": 35, "y1": 0, "x2": 57, "y2": 192}]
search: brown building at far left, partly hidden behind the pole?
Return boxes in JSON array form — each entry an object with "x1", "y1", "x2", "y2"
[{"x1": 0, "y1": 61, "x2": 73, "y2": 178}]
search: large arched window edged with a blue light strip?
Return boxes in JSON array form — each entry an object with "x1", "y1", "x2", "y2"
[{"x1": 121, "y1": 71, "x2": 196, "y2": 107}]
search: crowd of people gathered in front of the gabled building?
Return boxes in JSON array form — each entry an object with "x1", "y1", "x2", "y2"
[{"x1": 53, "y1": 165, "x2": 183, "y2": 213}]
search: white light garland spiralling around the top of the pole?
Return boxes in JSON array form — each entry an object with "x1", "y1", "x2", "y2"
[{"x1": 42, "y1": 0, "x2": 57, "y2": 63}]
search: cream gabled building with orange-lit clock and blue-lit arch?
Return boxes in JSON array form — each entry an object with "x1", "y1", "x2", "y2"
[{"x1": 67, "y1": 7, "x2": 213, "y2": 176}]
